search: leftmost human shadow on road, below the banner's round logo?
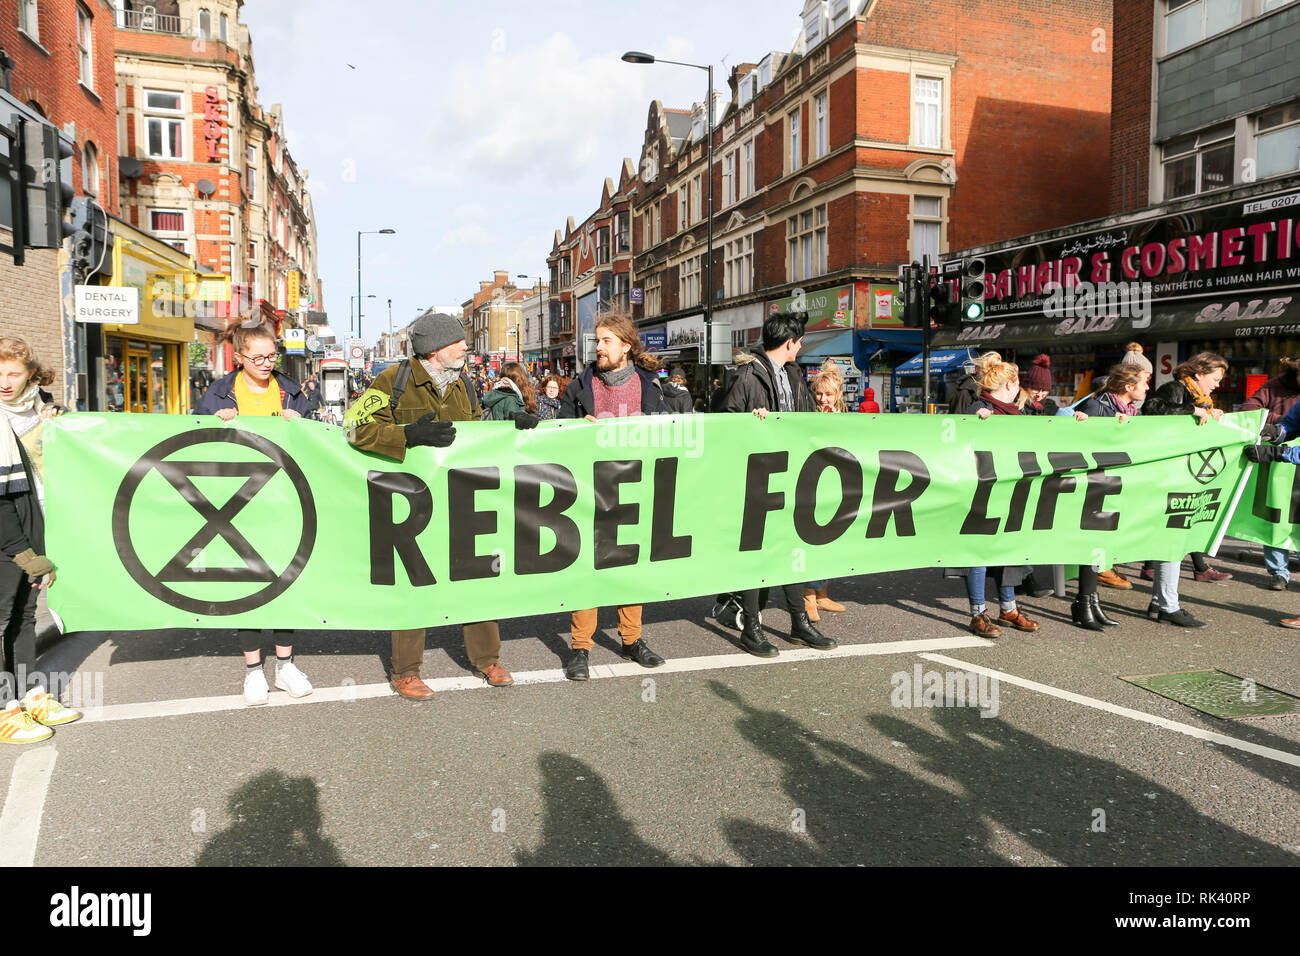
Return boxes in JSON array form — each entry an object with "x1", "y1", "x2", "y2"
[{"x1": 195, "y1": 770, "x2": 345, "y2": 866}]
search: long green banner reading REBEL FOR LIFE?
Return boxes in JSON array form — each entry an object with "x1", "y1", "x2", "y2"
[{"x1": 46, "y1": 412, "x2": 1262, "y2": 630}]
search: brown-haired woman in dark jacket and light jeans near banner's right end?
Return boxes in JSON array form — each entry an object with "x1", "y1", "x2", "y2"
[{"x1": 1143, "y1": 352, "x2": 1232, "y2": 627}]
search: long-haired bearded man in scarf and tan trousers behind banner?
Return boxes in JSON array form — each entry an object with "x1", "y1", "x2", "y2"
[{"x1": 559, "y1": 310, "x2": 668, "y2": 680}]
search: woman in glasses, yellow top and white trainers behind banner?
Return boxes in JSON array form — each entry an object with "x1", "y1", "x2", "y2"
[{"x1": 194, "y1": 321, "x2": 312, "y2": 706}]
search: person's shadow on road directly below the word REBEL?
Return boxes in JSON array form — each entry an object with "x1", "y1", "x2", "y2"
[{"x1": 515, "y1": 750, "x2": 673, "y2": 866}]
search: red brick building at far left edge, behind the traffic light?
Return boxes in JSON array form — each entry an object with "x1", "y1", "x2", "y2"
[{"x1": 0, "y1": 0, "x2": 118, "y2": 403}]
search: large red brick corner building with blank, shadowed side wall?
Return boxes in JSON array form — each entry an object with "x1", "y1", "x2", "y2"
[{"x1": 603, "y1": 0, "x2": 1110, "y2": 403}]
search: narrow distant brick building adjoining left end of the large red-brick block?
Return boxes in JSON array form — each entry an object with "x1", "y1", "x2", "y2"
[{"x1": 546, "y1": 160, "x2": 637, "y2": 375}]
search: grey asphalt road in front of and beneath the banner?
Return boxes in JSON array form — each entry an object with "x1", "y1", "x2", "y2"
[{"x1": 0, "y1": 546, "x2": 1300, "y2": 866}]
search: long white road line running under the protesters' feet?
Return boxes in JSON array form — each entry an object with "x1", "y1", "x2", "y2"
[{"x1": 78, "y1": 636, "x2": 992, "y2": 724}]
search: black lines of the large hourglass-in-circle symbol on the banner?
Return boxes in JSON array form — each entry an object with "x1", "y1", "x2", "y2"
[{"x1": 113, "y1": 428, "x2": 316, "y2": 617}]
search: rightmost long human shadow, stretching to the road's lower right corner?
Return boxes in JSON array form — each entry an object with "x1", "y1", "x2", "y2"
[{"x1": 867, "y1": 708, "x2": 1300, "y2": 866}]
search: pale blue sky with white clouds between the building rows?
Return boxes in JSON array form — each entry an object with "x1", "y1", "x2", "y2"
[{"x1": 242, "y1": 0, "x2": 802, "y2": 342}]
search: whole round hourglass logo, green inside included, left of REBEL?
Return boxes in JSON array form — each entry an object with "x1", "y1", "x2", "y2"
[{"x1": 113, "y1": 428, "x2": 317, "y2": 615}]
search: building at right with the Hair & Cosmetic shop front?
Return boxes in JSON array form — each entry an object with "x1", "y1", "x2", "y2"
[{"x1": 936, "y1": 0, "x2": 1300, "y2": 410}]
